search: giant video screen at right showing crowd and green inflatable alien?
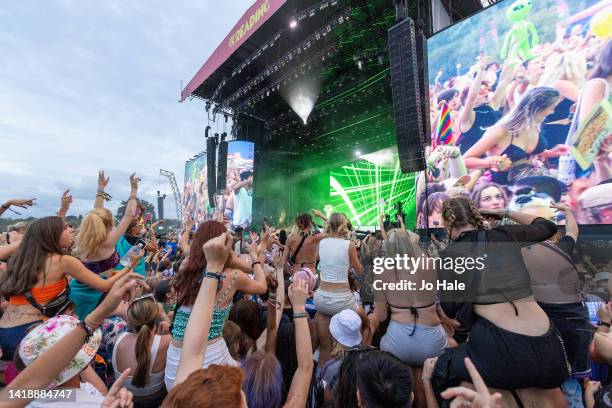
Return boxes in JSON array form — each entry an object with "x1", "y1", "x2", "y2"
[{"x1": 417, "y1": 0, "x2": 612, "y2": 227}]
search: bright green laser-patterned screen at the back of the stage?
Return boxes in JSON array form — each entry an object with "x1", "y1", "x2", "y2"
[{"x1": 328, "y1": 146, "x2": 415, "y2": 230}]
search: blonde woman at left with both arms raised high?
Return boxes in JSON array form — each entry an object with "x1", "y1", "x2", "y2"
[{"x1": 70, "y1": 171, "x2": 140, "y2": 317}]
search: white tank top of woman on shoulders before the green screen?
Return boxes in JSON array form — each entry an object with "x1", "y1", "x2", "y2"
[{"x1": 319, "y1": 238, "x2": 351, "y2": 283}]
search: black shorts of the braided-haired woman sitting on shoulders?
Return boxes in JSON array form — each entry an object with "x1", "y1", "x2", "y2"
[{"x1": 431, "y1": 316, "x2": 569, "y2": 394}]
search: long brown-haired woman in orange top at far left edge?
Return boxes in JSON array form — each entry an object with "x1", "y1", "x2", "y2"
[{"x1": 0, "y1": 217, "x2": 136, "y2": 360}]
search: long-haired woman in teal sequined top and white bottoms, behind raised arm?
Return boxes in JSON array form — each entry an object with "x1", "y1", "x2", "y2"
[{"x1": 165, "y1": 221, "x2": 269, "y2": 390}]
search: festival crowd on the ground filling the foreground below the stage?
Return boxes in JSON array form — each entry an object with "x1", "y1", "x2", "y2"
[{"x1": 0, "y1": 168, "x2": 612, "y2": 408}]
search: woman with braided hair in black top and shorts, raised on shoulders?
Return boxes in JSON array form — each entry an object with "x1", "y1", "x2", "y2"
[{"x1": 425, "y1": 197, "x2": 569, "y2": 404}]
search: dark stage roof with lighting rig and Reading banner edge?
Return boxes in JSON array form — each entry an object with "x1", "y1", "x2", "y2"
[{"x1": 182, "y1": 0, "x2": 486, "y2": 161}]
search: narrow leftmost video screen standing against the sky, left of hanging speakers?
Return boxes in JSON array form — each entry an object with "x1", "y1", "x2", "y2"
[{"x1": 183, "y1": 153, "x2": 210, "y2": 223}]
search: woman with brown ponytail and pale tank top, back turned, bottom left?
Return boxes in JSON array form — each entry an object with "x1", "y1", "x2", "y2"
[{"x1": 113, "y1": 294, "x2": 170, "y2": 407}]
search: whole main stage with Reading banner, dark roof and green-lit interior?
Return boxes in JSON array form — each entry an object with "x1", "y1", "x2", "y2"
[{"x1": 182, "y1": 0, "x2": 415, "y2": 230}]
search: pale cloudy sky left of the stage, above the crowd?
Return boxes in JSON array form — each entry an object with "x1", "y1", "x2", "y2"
[{"x1": 0, "y1": 0, "x2": 253, "y2": 218}]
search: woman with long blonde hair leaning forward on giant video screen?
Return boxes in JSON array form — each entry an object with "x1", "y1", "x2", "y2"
[{"x1": 464, "y1": 87, "x2": 569, "y2": 184}]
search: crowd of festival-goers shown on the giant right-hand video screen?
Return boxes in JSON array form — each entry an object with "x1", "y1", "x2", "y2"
[{"x1": 417, "y1": 20, "x2": 612, "y2": 227}]
